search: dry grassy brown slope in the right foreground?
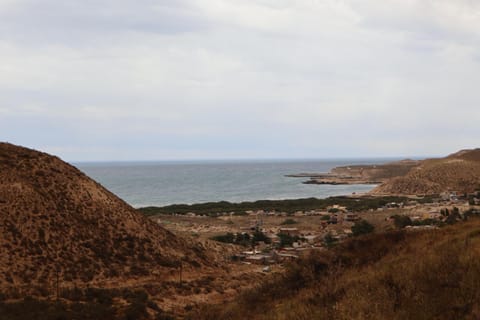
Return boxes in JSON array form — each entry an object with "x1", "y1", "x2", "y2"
[{"x1": 191, "y1": 219, "x2": 480, "y2": 320}]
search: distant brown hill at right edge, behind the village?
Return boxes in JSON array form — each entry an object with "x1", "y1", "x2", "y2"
[{"x1": 372, "y1": 149, "x2": 480, "y2": 194}]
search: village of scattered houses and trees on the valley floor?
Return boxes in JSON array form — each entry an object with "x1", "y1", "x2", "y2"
[{"x1": 152, "y1": 192, "x2": 480, "y2": 272}]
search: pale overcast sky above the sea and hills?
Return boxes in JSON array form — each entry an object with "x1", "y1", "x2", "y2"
[{"x1": 0, "y1": 0, "x2": 480, "y2": 161}]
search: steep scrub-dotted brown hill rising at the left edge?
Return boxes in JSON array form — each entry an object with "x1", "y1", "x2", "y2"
[{"x1": 0, "y1": 143, "x2": 211, "y2": 291}]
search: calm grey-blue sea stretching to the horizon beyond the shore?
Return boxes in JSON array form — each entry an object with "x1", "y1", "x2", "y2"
[{"x1": 74, "y1": 159, "x2": 393, "y2": 207}]
